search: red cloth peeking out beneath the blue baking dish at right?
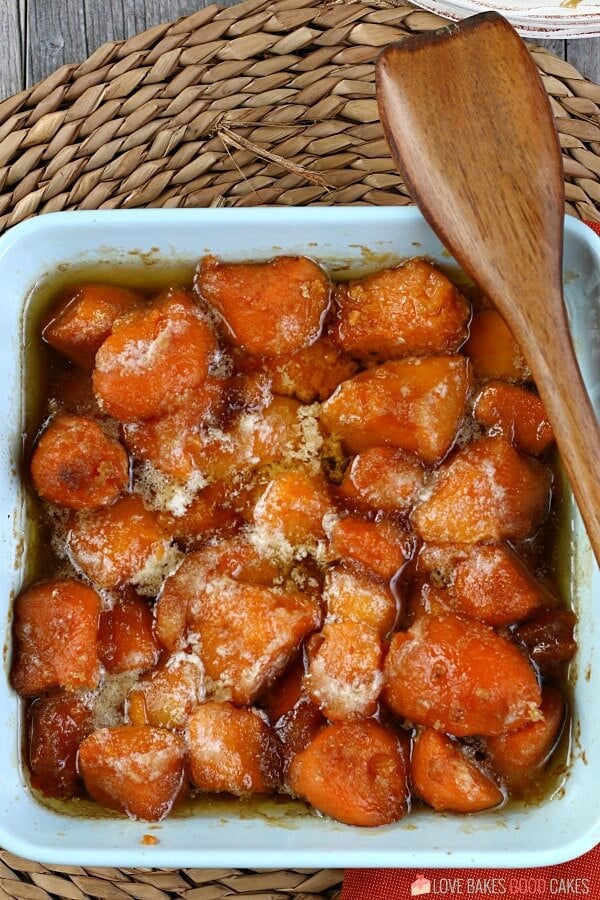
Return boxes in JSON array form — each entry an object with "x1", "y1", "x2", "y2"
[{"x1": 341, "y1": 216, "x2": 600, "y2": 900}]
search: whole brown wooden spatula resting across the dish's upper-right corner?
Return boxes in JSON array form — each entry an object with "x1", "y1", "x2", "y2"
[{"x1": 377, "y1": 12, "x2": 600, "y2": 563}]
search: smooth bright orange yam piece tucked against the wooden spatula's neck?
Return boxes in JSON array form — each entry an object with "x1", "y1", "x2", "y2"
[{"x1": 463, "y1": 309, "x2": 531, "y2": 381}]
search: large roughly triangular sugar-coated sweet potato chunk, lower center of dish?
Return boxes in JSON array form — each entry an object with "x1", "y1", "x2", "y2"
[{"x1": 156, "y1": 553, "x2": 320, "y2": 705}]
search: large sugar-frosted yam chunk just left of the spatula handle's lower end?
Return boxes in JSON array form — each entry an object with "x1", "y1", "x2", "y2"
[{"x1": 412, "y1": 437, "x2": 552, "y2": 544}]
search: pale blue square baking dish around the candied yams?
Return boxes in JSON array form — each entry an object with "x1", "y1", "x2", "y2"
[{"x1": 0, "y1": 207, "x2": 600, "y2": 868}]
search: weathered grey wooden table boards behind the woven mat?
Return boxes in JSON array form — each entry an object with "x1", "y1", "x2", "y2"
[{"x1": 0, "y1": 0, "x2": 600, "y2": 99}]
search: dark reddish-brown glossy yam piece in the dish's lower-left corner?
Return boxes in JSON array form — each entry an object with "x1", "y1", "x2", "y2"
[{"x1": 27, "y1": 694, "x2": 92, "y2": 800}]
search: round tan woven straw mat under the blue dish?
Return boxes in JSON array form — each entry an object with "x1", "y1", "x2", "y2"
[{"x1": 0, "y1": 0, "x2": 600, "y2": 900}]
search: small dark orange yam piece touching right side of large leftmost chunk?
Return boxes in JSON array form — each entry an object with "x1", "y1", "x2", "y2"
[{"x1": 98, "y1": 591, "x2": 160, "y2": 675}]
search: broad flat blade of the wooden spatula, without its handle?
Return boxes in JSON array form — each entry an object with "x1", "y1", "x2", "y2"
[{"x1": 377, "y1": 13, "x2": 564, "y2": 332}]
